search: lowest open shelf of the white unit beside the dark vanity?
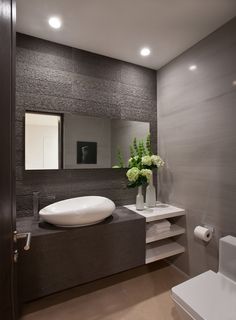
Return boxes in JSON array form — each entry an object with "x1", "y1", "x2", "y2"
[{"x1": 146, "y1": 239, "x2": 185, "y2": 264}]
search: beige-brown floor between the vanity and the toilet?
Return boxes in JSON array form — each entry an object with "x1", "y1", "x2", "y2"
[{"x1": 21, "y1": 262, "x2": 186, "y2": 320}]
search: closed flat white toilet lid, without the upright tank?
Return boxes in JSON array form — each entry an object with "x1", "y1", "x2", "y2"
[{"x1": 172, "y1": 271, "x2": 236, "y2": 320}]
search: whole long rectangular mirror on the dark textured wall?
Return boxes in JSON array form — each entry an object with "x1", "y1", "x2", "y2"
[{"x1": 25, "y1": 113, "x2": 150, "y2": 170}]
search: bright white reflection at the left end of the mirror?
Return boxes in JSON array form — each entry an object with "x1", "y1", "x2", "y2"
[{"x1": 25, "y1": 112, "x2": 61, "y2": 170}]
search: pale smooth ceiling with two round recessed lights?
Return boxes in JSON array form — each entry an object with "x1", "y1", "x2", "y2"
[{"x1": 17, "y1": 0, "x2": 236, "y2": 69}]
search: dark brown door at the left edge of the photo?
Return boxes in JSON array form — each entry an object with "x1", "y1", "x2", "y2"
[{"x1": 0, "y1": 0, "x2": 16, "y2": 320}]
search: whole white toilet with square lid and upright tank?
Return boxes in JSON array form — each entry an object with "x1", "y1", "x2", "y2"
[{"x1": 171, "y1": 236, "x2": 236, "y2": 320}]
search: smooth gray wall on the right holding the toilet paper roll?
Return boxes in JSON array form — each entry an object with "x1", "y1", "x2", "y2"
[{"x1": 157, "y1": 18, "x2": 236, "y2": 275}]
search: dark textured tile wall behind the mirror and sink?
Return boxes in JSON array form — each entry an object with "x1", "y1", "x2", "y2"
[{"x1": 16, "y1": 34, "x2": 157, "y2": 217}]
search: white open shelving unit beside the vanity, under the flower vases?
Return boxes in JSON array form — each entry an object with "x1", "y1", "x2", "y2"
[{"x1": 126, "y1": 202, "x2": 185, "y2": 264}]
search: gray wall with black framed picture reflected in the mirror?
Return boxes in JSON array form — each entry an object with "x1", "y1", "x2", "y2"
[{"x1": 63, "y1": 114, "x2": 150, "y2": 169}]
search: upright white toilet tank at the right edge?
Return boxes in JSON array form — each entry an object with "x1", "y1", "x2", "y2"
[{"x1": 219, "y1": 236, "x2": 236, "y2": 282}]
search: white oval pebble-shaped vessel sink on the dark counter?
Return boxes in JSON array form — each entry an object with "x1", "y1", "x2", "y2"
[{"x1": 39, "y1": 196, "x2": 115, "y2": 227}]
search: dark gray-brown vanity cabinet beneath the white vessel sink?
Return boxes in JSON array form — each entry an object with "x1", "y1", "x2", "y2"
[{"x1": 18, "y1": 207, "x2": 145, "y2": 302}]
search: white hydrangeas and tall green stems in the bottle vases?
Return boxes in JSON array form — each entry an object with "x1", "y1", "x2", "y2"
[{"x1": 126, "y1": 134, "x2": 165, "y2": 188}]
